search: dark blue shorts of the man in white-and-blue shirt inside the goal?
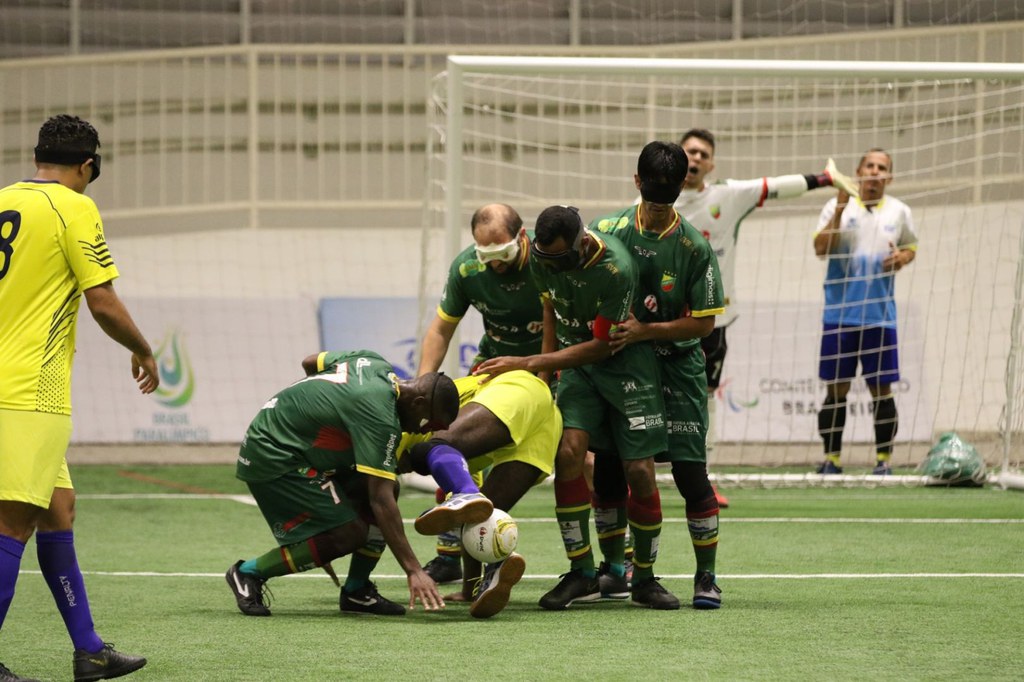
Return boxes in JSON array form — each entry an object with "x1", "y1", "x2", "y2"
[{"x1": 818, "y1": 324, "x2": 899, "y2": 386}]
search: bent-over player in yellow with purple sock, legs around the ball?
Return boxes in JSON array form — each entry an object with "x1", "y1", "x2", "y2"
[{"x1": 398, "y1": 370, "x2": 562, "y2": 619}]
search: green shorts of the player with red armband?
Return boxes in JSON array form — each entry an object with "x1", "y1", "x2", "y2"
[{"x1": 558, "y1": 343, "x2": 669, "y2": 460}]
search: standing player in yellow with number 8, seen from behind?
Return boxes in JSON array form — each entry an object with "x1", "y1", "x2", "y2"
[{"x1": 0, "y1": 115, "x2": 160, "y2": 682}]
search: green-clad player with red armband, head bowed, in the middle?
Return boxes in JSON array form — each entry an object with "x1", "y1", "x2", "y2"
[{"x1": 477, "y1": 206, "x2": 679, "y2": 610}]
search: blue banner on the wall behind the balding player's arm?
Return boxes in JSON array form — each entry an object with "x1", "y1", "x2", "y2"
[{"x1": 319, "y1": 298, "x2": 483, "y2": 379}]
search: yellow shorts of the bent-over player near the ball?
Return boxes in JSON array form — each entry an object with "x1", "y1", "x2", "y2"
[{"x1": 469, "y1": 372, "x2": 562, "y2": 482}]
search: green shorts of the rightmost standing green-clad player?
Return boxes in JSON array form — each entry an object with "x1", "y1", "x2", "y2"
[{"x1": 655, "y1": 346, "x2": 708, "y2": 462}]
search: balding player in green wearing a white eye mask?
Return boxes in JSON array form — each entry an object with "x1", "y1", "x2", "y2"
[{"x1": 419, "y1": 204, "x2": 544, "y2": 583}]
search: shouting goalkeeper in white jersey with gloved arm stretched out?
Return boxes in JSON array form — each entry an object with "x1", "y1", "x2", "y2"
[{"x1": 675, "y1": 128, "x2": 857, "y2": 499}]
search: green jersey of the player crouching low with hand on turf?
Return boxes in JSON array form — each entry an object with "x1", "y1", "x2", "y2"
[{"x1": 236, "y1": 350, "x2": 401, "y2": 482}]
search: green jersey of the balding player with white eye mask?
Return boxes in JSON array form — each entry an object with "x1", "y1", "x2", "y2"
[{"x1": 437, "y1": 240, "x2": 544, "y2": 361}]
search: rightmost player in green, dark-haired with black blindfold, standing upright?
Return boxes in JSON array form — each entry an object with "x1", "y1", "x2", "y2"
[{"x1": 591, "y1": 141, "x2": 725, "y2": 608}]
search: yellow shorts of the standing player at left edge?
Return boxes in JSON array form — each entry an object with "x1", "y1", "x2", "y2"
[{"x1": 0, "y1": 410, "x2": 73, "y2": 508}]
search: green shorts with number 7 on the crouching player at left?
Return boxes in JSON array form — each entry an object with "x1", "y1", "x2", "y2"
[{"x1": 246, "y1": 468, "x2": 366, "y2": 547}]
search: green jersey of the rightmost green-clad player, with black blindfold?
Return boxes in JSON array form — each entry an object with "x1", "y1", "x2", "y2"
[{"x1": 591, "y1": 205, "x2": 725, "y2": 354}]
